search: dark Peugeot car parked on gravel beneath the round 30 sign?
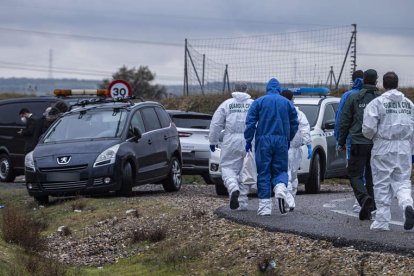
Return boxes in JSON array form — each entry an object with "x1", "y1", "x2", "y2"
[{"x1": 25, "y1": 99, "x2": 182, "y2": 204}]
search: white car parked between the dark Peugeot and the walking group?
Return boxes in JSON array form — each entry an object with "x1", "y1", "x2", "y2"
[{"x1": 167, "y1": 110, "x2": 213, "y2": 184}]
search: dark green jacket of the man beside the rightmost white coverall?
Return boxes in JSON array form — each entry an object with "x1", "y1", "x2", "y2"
[{"x1": 338, "y1": 84, "x2": 380, "y2": 145}]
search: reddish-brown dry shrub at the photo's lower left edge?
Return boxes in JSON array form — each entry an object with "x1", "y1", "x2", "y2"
[{"x1": 1, "y1": 206, "x2": 47, "y2": 251}]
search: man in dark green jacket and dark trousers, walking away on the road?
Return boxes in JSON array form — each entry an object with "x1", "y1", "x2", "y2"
[{"x1": 338, "y1": 69, "x2": 380, "y2": 220}]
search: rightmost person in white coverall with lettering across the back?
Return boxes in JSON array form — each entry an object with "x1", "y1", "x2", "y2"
[{"x1": 362, "y1": 72, "x2": 414, "y2": 230}]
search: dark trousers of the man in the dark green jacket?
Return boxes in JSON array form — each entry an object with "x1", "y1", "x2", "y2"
[{"x1": 348, "y1": 144, "x2": 374, "y2": 206}]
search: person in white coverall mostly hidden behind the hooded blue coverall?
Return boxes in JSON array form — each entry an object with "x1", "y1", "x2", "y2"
[{"x1": 280, "y1": 90, "x2": 312, "y2": 211}]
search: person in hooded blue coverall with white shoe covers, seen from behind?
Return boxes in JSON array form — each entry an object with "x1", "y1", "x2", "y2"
[{"x1": 244, "y1": 78, "x2": 299, "y2": 216}]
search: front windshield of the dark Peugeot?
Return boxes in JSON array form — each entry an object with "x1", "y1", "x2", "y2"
[{"x1": 43, "y1": 109, "x2": 127, "y2": 143}]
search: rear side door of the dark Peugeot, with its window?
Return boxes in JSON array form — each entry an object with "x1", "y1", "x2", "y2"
[{"x1": 141, "y1": 107, "x2": 168, "y2": 178}]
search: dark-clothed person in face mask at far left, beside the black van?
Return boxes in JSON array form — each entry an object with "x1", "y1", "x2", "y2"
[{"x1": 18, "y1": 108, "x2": 42, "y2": 154}]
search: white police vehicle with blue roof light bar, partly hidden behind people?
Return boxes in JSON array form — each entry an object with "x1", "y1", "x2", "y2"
[{"x1": 209, "y1": 88, "x2": 347, "y2": 195}]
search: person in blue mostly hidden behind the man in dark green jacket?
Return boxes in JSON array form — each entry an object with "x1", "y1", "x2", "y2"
[{"x1": 334, "y1": 70, "x2": 364, "y2": 213}]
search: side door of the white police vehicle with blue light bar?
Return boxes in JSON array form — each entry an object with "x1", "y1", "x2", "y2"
[{"x1": 322, "y1": 103, "x2": 346, "y2": 176}]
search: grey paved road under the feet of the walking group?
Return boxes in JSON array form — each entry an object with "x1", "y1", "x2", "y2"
[{"x1": 216, "y1": 192, "x2": 414, "y2": 255}]
